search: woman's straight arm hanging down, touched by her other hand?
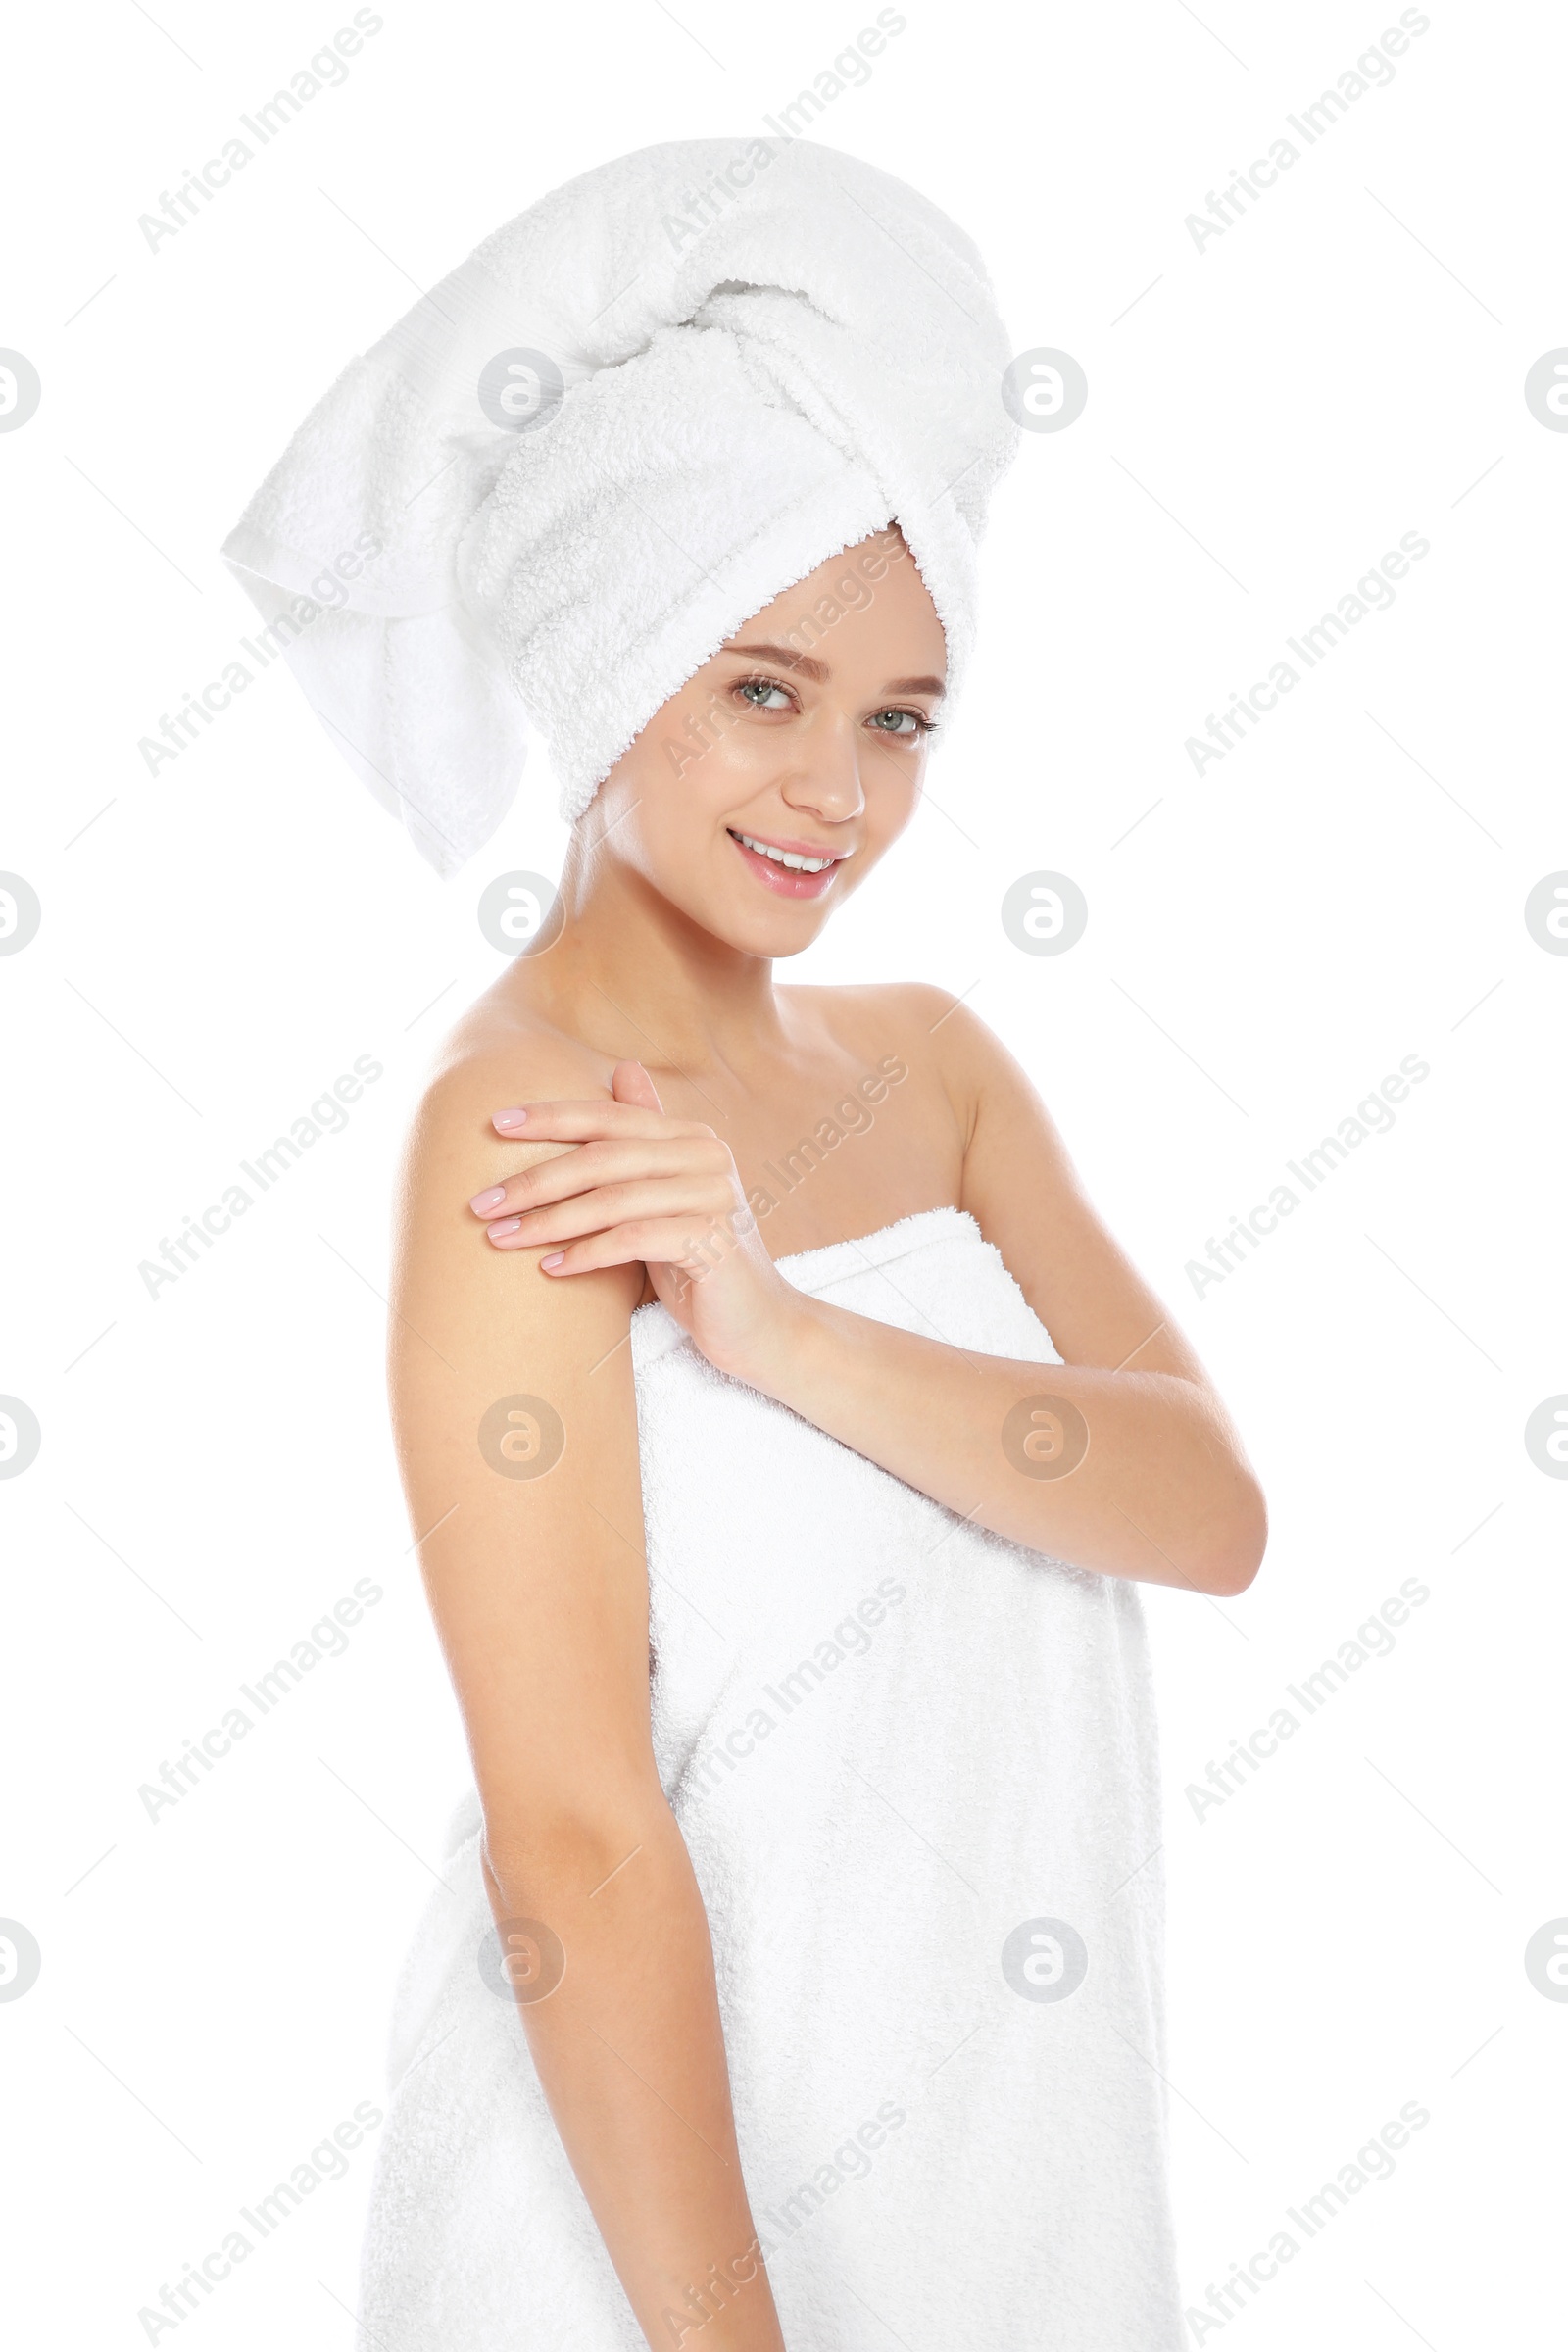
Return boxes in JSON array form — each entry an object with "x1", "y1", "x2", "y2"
[{"x1": 390, "y1": 1052, "x2": 783, "y2": 2352}]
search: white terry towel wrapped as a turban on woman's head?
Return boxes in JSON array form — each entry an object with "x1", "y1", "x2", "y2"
[{"x1": 223, "y1": 139, "x2": 1018, "y2": 875}]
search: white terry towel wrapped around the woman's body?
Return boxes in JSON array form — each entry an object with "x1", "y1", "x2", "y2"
[{"x1": 362, "y1": 1209, "x2": 1183, "y2": 2352}]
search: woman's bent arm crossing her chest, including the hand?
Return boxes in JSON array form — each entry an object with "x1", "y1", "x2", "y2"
[{"x1": 472, "y1": 1020, "x2": 1267, "y2": 1597}]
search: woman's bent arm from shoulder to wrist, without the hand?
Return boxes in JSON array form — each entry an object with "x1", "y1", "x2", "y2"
[{"x1": 748, "y1": 990, "x2": 1267, "y2": 1594}]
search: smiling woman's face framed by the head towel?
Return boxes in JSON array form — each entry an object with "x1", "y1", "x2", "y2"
[{"x1": 583, "y1": 527, "x2": 948, "y2": 957}]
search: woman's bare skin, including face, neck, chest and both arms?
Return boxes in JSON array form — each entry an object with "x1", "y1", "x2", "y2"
[{"x1": 390, "y1": 531, "x2": 1265, "y2": 2352}]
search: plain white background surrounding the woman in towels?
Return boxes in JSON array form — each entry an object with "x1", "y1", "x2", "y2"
[{"x1": 0, "y1": 0, "x2": 1568, "y2": 2352}]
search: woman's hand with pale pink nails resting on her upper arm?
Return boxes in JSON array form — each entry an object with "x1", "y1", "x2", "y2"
[{"x1": 467, "y1": 1060, "x2": 800, "y2": 1378}]
